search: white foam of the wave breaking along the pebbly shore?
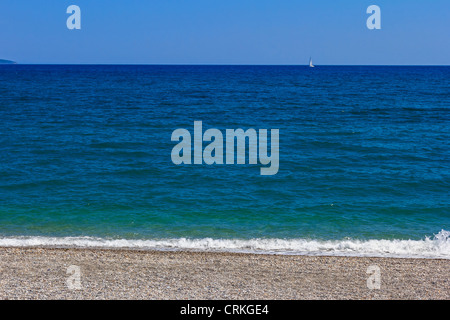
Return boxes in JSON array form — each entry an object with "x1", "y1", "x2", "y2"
[{"x1": 0, "y1": 230, "x2": 450, "y2": 259}]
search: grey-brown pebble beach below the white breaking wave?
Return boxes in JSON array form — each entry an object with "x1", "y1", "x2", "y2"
[{"x1": 0, "y1": 248, "x2": 450, "y2": 299}]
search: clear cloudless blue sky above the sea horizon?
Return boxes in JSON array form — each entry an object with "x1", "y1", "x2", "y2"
[{"x1": 0, "y1": 0, "x2": 450, "y2": 65}]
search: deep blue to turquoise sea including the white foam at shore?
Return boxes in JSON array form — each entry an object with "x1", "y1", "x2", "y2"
[{"x1": 0, "y1": 65, "x2": 450, "y2": 259}]
